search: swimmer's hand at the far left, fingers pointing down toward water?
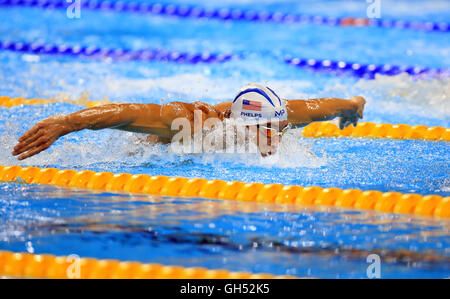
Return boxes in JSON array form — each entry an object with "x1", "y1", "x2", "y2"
[{"x1": 12, "y1": 116, "x2": 72, "y2": 160}]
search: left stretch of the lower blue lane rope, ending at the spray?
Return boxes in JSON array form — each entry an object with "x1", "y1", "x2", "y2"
[{"x1": 0, "y1": 41, "x2": 238, "y2": 64}]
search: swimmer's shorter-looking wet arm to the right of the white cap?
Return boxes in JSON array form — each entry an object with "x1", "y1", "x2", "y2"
[{"x1": 286, "y1": 96, "x2": 366, "y2": 129}]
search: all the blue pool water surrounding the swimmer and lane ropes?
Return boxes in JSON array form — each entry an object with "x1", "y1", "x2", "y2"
[{"x1": 0, "y1": 0, "x2": 450, "y2": 278}]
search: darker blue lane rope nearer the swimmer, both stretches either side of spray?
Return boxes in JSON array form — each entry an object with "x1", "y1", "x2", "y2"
[{"x1": 0, "y1": 41, "x2": 450, "y2": 79}]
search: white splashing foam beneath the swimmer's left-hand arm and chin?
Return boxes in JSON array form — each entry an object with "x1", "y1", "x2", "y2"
[{"x1": 0, "y1": 117, "x2": 326, "y2": 169}]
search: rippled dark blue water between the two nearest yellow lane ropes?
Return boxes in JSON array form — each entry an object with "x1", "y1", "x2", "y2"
[{"x1": 0, "y1": 184, "x2": 450, "y2": 278}]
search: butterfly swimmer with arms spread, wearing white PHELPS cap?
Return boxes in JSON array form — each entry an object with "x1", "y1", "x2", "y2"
[{"x1": 12, "y1": 83, "x2": 366, "y2": 160}]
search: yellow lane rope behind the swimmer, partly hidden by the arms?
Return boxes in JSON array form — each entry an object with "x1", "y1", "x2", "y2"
[{"x1": 0, "y1": 96, "x2": 450, "y2": 141}]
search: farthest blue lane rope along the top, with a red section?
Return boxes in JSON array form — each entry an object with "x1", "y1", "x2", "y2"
[{"x1": 0, "y1": 0, "x2": 450, "y2": 32}]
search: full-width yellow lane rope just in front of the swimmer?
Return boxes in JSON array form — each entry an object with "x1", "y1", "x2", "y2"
[{"x1": 0, "y1": 166, "x2": 450, "y2": 218}]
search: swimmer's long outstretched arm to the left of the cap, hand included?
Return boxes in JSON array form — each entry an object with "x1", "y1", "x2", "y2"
[{"x1": 12, "y1": 102, "x2": 211, "y2": 160}]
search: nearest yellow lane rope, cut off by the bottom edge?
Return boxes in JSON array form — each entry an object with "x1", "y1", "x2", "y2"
[{"x1": 0, "y1": 251, "x2": 296, "y2": 279}]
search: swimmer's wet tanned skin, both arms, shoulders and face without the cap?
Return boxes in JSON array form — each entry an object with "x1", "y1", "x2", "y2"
[{"x1": 12, "y1": 96, "x2": 366, "y2": 160}]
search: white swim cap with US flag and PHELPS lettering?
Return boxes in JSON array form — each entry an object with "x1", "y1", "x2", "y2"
[{"x1": 231, "y1": 83, "x2": 287, "y2": 125}]
